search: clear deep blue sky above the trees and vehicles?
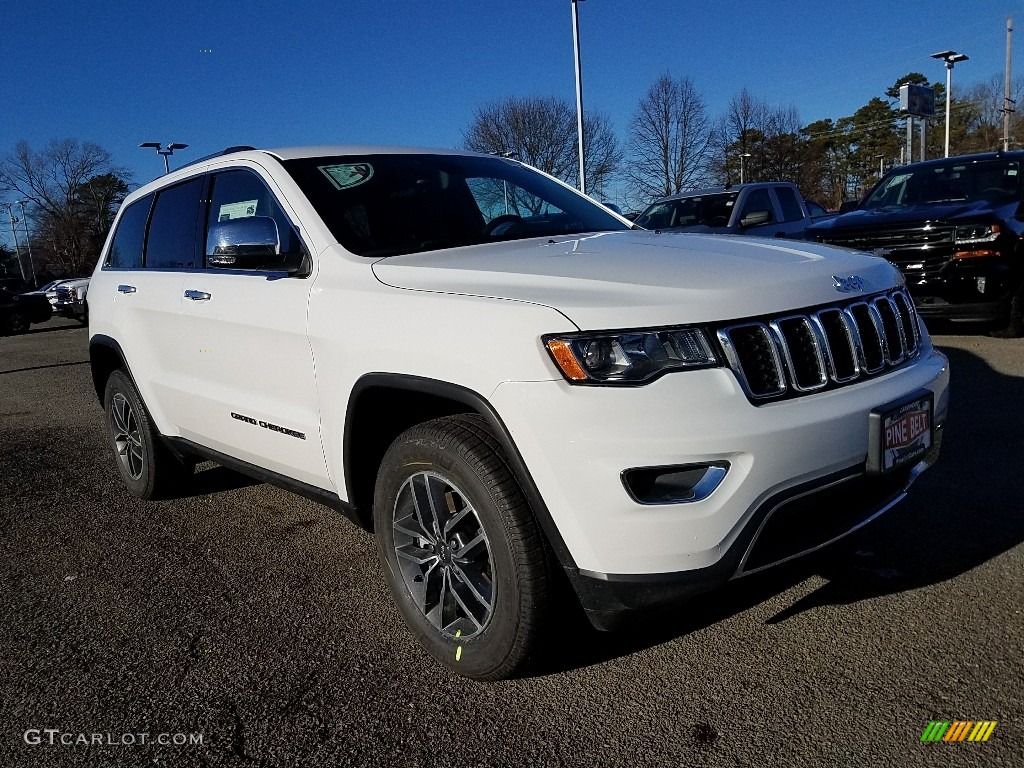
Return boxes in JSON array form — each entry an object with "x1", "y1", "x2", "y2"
[{"x1": 0, "y1": 0, "x2": 1024, "y2": 238}]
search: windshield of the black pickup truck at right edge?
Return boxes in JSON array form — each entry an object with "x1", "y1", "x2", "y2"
[{"x1": 860, "y1": 159, "x2": 1021, "y2": 210}]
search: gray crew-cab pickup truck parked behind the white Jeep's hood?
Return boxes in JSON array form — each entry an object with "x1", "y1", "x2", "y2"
[{"x1": 635, "y1": 181, "x2": 834, "y2": 238}]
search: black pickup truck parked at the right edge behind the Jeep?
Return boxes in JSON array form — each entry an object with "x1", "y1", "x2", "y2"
[{"x1": 806, "y1": 152, "x2": 1024, "y2": 337}]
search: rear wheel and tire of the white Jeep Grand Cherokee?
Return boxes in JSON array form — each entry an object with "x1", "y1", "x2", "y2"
[{"x1": 103, "y1": 370, "x2": 193, "y2": 499}]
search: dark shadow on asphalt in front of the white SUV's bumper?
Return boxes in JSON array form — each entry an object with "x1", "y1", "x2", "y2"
[{"x1": 535, "y1": 348, "x2": 1024, "y2": 675}]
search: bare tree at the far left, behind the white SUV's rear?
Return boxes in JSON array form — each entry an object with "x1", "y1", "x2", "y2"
[{"x1": 0, "y1": 138, "x2": 128, "y2": 274}]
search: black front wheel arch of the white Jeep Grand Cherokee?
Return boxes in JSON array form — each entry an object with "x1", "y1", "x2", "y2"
[{"x1": 343, "y1": 373, "x2": 578, "y2": 575}]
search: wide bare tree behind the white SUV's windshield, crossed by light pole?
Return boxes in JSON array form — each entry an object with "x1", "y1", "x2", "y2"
[{"x1": 463, "y1": 96, "x2": 622, "y2": 196}]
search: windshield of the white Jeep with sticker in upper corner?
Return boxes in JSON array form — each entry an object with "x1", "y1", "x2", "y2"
[{"x1": 284, "y1": 155, "x2": 629, "y2": 256}]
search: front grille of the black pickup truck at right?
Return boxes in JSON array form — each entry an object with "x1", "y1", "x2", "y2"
[{"x1": 821, "y1": 223, "x2": 953, "y2": 282}]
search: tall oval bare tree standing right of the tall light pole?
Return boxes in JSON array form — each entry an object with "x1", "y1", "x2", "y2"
[{"x1": 627, "y1": 75, "x2": 711, "y2": 200}]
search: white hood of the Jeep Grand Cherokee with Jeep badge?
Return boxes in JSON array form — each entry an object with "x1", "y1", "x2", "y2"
[{"x1": 373, "y1": 230, "x2": 902, "y2": 330}]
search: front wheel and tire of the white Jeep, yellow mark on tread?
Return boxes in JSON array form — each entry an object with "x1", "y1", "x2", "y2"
[{"x1": 374, "y1": 415, "x2": 552, "y2": 680}]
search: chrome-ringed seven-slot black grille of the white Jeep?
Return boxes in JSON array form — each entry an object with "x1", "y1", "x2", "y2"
[{"x1": 718, "y1": 289, "x2": 921, "y2": 403}]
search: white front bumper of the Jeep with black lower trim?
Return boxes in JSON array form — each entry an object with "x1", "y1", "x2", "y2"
[{"x1": 492, "y1": 343, "x2": 949, "y2": 628}]
